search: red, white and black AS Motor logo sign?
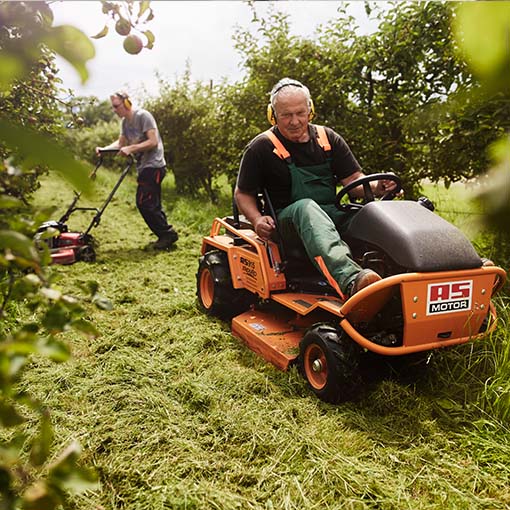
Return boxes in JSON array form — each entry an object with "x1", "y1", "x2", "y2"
[{"x1": 427, "y1": 280, "x2": 473, "y2": 315}]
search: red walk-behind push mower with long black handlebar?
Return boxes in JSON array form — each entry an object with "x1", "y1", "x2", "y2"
[{"x1": 35, "y1": 149, "x2": 134, "y2": 264}]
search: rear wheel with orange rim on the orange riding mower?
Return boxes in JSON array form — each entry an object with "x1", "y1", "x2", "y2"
[{"x1": 197, "y1": 250, "x2": 255, "y2": 319}]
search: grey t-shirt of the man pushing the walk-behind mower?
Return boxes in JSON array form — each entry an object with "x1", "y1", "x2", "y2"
[{"x1": 121, "y1": 109, "x2": 166, "y2": 173}]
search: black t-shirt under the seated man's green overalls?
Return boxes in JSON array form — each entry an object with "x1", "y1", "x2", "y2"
[{"x1": 237, "y1": 124, "x2": 361, "y2": 209}]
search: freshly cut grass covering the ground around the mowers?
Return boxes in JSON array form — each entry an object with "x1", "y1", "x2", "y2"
[{"x1": 19, "y1": 171, "x2": 510, "y2": 510}]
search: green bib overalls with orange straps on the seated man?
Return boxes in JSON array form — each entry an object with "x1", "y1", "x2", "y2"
[{"x1": 266, "y1": 126, "x2": 361, "y2": 293}]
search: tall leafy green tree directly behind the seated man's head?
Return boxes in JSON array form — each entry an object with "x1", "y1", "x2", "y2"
[{"x1": 224, "y1": 2, "x2": 510, "y2": 196}]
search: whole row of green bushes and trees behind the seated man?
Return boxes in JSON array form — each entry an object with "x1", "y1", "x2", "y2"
[{"x1": 131, "y1": 2, "x2": 510, "y2": 204}]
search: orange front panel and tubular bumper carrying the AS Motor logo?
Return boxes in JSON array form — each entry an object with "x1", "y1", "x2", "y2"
[{"x1": 340, "y1": 266, "x2": 506, "y2": 355}]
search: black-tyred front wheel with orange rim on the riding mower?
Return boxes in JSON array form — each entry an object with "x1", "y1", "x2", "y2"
[{"x1": 299, "y1": 323, "x2": 362, "y2": 404}]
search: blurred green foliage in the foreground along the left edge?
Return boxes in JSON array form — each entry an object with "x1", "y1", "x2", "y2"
[{"x1": 0, "y1": 2, "x2": 155, "y2": 510}]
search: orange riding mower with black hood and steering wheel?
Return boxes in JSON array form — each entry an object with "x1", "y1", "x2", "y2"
[{"x1": 197, "y1": 174, "x2": 506, "y2": 403}]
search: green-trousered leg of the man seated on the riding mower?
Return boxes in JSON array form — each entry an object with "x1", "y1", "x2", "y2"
[{"x1": 278, "y1": 198, "x2": 361, "y2": 294}]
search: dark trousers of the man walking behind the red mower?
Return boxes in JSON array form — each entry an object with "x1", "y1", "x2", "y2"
[{"x1": 136, "y1": 168, "x2": 172, "y2": 237}]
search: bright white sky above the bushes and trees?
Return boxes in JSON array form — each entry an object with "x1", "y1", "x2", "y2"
[{"x1": 51, "y1": 0, "x2": 375, "y2": 99}]
